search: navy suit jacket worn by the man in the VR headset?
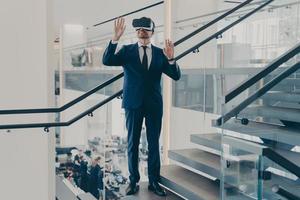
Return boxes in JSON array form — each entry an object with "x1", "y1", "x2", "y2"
[{"x1": 102, "y1": 42, "x2": 181, "y2": 109}]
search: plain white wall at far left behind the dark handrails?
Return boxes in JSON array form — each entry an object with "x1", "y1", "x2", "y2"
[{"x1": 0, "y1": 0, "x2": 55, "y2": 200}]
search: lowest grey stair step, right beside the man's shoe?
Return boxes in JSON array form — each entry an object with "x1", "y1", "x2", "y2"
[{"x1": 160, "y1": 165, "x2": 250, "y2": 200}]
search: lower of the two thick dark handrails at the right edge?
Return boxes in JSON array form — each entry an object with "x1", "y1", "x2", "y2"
[{"x1": 213, "y1": 61, "x2": 300, "y2": 126}]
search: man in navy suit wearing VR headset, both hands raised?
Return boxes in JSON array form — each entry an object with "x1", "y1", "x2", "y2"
[{"x1": 103, "y1": 17, "x2": 181, "y2": 196}]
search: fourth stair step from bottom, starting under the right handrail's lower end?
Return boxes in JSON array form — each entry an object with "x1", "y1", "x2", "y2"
[{"x1": 219, "y1": 118, "x2": 300, "y2": 146}]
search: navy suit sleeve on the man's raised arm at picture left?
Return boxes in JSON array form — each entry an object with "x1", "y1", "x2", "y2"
[{"x1": 102, "y1": 41, "x2": 125, "y2": 66}]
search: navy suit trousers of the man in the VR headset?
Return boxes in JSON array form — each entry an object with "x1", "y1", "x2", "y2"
[{"x1": 125, "y1": 103, "x2": 162, "y2": 183}]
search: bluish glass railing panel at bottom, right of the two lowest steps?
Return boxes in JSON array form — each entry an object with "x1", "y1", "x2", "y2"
[{"x1": 221, "y1": 136, "x2": 264, "y2": 199}]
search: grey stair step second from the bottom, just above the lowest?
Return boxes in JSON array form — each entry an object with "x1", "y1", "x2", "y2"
[{"x1": 168, "y1": 149, "x2": 221, "y2": 179}]
